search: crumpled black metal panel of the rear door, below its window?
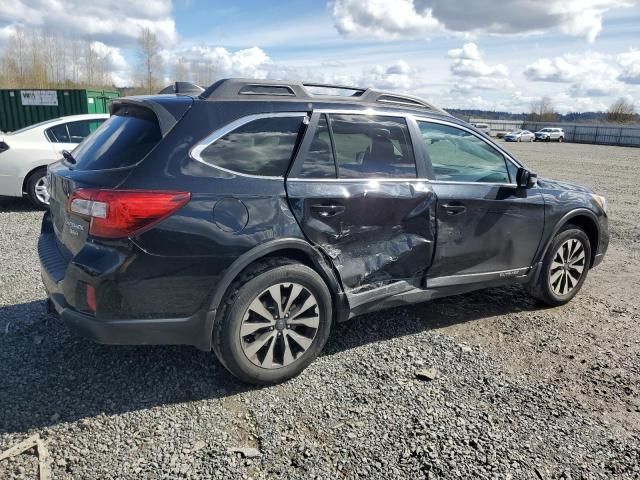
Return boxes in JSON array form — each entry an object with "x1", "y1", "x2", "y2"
[{"x1": 287, "y1": 179, "x2": 436, "y2": 293}]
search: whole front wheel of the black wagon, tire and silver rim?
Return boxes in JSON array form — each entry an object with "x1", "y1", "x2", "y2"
[{"x1": 530, "y1": 225, "x2": 591, "y2": 307}]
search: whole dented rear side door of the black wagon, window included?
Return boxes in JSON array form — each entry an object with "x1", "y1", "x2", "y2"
[{"x1": 287, "y1": 111, "x2": 436, "y2": 294}]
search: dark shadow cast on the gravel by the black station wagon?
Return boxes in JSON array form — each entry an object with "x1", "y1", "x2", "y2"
[{"x1": 0, "y1": 287, "x2": 536, "y2": 433}]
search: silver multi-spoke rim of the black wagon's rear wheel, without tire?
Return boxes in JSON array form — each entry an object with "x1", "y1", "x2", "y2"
[{"x1": 240, "y1": 283, "x2": 322, "y2": 369}]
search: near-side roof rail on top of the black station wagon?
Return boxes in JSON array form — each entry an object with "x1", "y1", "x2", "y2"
[{"x1": 200, "y1": 78, "x2": 449, "y2": 115}]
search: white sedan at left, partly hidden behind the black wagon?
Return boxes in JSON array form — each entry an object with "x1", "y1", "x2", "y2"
[{"x1": 0, "y1": 114, "x2": 109, "y2": 208}]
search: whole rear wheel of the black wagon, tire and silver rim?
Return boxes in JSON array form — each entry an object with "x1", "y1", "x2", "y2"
[{"x1": 213, "y1": 262, "x2": 333, "y2": 385}]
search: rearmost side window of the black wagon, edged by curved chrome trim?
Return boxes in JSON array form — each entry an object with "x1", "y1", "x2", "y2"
[{"x1": 194, "y1": 113, "x2": 306, "y2": 177}]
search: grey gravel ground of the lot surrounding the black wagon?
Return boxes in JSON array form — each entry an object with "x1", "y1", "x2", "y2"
[{"x1": 0, "y1": 143, "x2": 640, "y2": 479}]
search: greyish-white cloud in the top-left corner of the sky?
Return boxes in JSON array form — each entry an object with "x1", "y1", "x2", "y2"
[{"x1": 0, "y1": 0, "x2": 177, "y2": 46}]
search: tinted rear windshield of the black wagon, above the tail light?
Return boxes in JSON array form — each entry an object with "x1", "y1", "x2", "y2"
[{"x1": 73, "y1": 107, "x2": 162, "y2": 170}]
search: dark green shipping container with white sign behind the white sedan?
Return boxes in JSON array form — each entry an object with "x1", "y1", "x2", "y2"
[{"x1": 0, "y1": 89, "x2": 120, "y2": 132}]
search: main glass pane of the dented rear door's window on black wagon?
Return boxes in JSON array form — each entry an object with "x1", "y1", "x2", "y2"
[{"x1": 329, "y1": 114, "x2": 417, "y2": 178}]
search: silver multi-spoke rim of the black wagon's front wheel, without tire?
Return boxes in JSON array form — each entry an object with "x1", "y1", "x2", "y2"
[{"x1": 549, "y1": 238, "x2": 586, "y2": 296}]
